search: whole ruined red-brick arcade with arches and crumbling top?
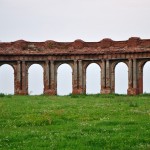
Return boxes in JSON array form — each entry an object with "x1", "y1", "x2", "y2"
[{"x1": 0, "y1": 37, "x2": 150, "y2": 95}]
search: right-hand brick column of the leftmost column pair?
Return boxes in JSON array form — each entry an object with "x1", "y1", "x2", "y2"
[{"x1": 21, "y1": 61, "x2": 28, "y2": 95}]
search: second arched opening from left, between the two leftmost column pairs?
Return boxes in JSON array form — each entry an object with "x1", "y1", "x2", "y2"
[{"x1": 28, "y1": 64, "x2": 44, "y2": 95}]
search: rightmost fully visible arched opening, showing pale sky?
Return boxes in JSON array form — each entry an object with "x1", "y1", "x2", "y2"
[{"x1": 115, "y1": 62, "x2": 128, "y2": 94}]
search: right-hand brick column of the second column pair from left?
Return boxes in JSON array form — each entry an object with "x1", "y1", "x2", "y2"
[{"x1": 48, "y1": 61, "x2": 57, "y2": 95}]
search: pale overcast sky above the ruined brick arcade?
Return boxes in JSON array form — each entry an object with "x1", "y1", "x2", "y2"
[{"x1": 0, "y1": 0, "x2": 150, "y2": 95}]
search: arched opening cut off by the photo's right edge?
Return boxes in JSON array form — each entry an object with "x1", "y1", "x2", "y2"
[{"x1": 143, "y1": 61, "x2": 150, "y2": 93}]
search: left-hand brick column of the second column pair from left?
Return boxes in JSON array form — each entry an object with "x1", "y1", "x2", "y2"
[{"x1": 44, "y1": 60, "x2": 50, "y2": 94}]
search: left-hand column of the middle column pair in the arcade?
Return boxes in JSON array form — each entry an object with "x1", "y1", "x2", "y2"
[{"x1": 73, "y1": 60, "x2": 78, "y2": 94}]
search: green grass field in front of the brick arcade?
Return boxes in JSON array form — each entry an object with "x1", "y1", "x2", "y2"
[{"x1": 0, "y1": 95, "x2": 150, "y2": 150}]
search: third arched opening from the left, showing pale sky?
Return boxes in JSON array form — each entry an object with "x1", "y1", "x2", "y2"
[{"x1": 57, "y1": 64, "x2": 72, "y2": 95}]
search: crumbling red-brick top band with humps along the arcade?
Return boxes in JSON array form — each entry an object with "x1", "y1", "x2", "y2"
[{"x1": 0, "y1": 37, "x2": 150, "y2": 55}]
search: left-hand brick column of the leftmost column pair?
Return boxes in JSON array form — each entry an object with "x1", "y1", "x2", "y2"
[{"x1": 14, "y1": 61, "x2": 21, "y2": 95}]
